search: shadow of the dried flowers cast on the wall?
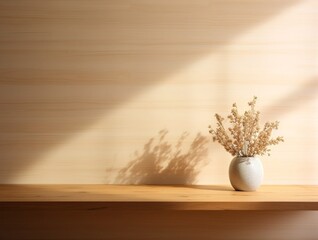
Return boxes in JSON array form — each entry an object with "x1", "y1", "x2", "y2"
[{"x1": 110, "y1": 130, "x2": 209, "y2": 184}]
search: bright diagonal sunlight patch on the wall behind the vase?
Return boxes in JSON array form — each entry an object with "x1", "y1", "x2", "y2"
[{"x1": 11, "y1": 1, "x2": 318, "y2": 184}]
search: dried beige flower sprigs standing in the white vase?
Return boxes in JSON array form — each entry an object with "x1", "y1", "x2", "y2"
[{"x1": 209, "y1": 97, "x2": 284, "y2": 157}]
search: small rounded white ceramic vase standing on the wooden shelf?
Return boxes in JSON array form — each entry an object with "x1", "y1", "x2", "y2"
[{"x1": 229, "y1": 157, "x2": 264, "y2": 191}]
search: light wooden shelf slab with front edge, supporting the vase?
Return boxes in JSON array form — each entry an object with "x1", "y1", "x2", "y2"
[{"x1": 0, "y1": 185, "x2": 318, "y2": 210}]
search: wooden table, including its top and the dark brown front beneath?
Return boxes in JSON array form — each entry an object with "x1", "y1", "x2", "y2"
[{"x1": 0, "y1": 185, "x2": 318, "y2": 240}]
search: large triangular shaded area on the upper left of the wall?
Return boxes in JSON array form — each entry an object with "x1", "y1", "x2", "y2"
[{"x1": 0, "y1": 0, "x2": 301, "y2": 183}]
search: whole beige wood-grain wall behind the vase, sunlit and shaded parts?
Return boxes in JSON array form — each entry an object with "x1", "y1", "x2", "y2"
[{"x1": 0, "y1": 0, "x2": 318, "y2": 184}]
